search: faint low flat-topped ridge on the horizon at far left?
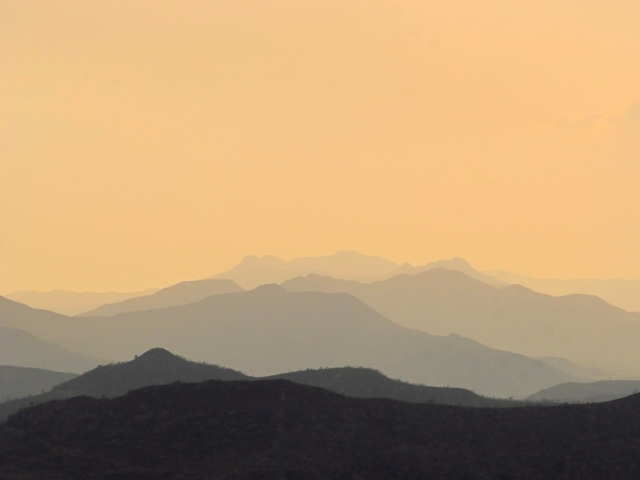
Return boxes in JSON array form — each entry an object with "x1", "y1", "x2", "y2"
[{"x1": 5, "y1": 288, "x2": 157, "y2": 315}]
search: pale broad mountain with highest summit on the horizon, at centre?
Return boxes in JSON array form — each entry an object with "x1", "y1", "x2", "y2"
[{"x1": 211, "y1": 251, "x2": 400, "y2": 289}]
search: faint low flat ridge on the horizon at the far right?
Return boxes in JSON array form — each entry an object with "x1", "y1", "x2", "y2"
[{"x1": 485, "y1": 270, "x2": 640, "y2": 312}]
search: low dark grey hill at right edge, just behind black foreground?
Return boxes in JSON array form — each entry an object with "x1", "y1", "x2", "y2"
[{"x1": 527, "y1": 380, "x2": 640, "y2": 402}]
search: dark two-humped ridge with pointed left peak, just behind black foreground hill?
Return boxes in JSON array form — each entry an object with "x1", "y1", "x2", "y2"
[{"x1": 0, "y1": 348, "x2": 520, "y2": 422}]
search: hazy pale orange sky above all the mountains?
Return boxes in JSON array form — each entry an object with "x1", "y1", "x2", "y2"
[{"x1": 0, "y1": 0, "x2": 640, "y2": 294}]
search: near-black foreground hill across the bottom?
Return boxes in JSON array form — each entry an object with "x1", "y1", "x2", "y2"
[{"x1": 0, "y1": 380, "x2": 640, "y2": 480}]
